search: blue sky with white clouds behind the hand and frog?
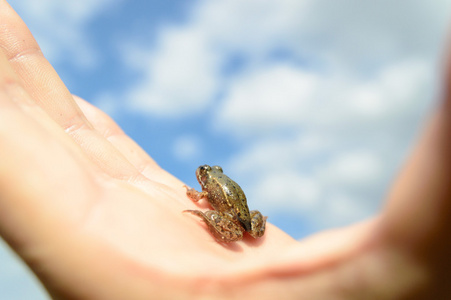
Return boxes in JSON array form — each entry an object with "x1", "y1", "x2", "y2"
[{"x1": 0, "y1": 0, "x2": 451, "y2": 299}]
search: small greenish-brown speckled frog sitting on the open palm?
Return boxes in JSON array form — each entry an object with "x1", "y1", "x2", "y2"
[{"x1": 183, "y1": 165, "x2": 268, "y2": 243}]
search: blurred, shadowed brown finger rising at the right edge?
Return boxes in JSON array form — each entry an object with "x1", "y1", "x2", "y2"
[{"x1": 383, "y1": 96, "x2": 451, "y2": 266}]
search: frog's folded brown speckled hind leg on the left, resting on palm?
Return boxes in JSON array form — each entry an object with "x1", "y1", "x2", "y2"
[{"x1": 183, "y1": 210, "x2": 244, "y2": 243}]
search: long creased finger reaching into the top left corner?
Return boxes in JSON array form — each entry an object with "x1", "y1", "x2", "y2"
[{"x1": 0, "y1": 0, "x2": 142, "y2": 181}]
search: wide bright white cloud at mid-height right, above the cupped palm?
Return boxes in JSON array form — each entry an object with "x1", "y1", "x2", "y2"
[{"x1": 214, "y1": 59, "x2": 436, "y2": 137}]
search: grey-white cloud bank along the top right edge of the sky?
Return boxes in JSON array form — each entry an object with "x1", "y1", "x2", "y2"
[{"x1": 195, "y1": 0, "x2": 451, "y2": 70}]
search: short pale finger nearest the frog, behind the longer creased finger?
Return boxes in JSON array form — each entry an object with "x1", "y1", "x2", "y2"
[{"x1": 74, "y1": 96, "x2": 183, "y2": 188}]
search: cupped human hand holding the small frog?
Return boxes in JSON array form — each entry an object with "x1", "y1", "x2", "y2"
[{"x1": 0, "y1": 0, "x2": 451, "y2": 299}]
